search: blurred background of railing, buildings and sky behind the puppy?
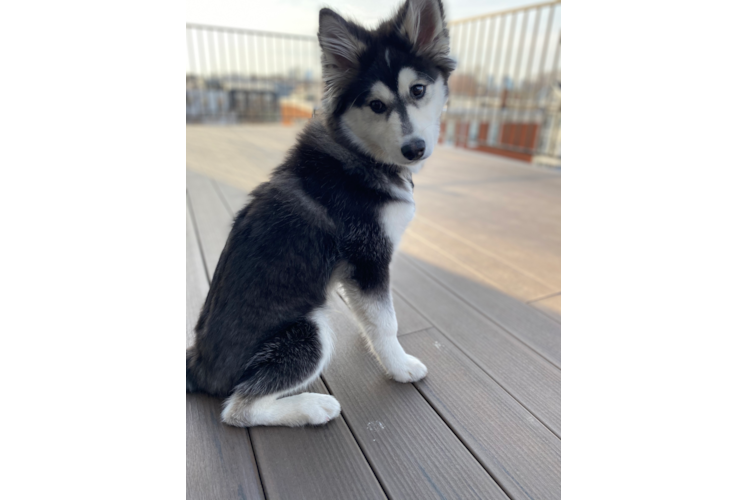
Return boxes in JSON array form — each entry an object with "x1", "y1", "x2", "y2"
[{"x1": 186, "y1": 0, "x2": 558, "y2": 165}]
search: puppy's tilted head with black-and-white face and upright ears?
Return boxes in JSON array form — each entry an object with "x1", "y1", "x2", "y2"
[{"x1": 318, "y1": 0, "x2": 455, "y2": 171}]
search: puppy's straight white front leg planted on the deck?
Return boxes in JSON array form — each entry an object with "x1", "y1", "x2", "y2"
[{"x1": 343, "y1": 282, "x2": 428, "y2": 382}]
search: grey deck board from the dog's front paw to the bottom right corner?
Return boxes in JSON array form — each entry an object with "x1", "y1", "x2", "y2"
[{"x1": 401, "y1": 328, "x2": 561, "y2": 500}]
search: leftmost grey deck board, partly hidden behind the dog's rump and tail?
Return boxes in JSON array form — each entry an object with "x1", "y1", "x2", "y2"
[{"x1": 185, "y1": 195, "x2": 265, "y2": 500}]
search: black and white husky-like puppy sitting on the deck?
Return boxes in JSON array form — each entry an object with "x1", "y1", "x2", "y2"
[{"x1": 187, "y1": 0, "x2": 455, "y2": 426}]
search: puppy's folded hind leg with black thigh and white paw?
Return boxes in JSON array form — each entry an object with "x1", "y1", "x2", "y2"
[{"x1": 221, "y1": 309, "x2": 340, "y2": 427}]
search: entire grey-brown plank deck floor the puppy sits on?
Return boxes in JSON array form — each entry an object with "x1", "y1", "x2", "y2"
[{"x1": 186, "y1": 126, "x2": 560, "y2": 500}]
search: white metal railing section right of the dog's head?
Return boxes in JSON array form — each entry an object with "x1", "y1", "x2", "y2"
[{"x1": 442, "y1": 2, "x2": 558, "y2": 160}]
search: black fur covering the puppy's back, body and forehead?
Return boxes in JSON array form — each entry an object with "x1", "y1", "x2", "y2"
[{"x1": 186, "y1": 0, "x2": 451, "y2": 397}]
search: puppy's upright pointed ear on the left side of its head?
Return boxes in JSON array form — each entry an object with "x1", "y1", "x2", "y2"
[{"x1": 317, "y1": 8, "x2": 366, "y2": 80}]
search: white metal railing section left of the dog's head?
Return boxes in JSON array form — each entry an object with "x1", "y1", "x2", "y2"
[{"x1": 186, "y1": 24, "x2": 321, "y2": 123}]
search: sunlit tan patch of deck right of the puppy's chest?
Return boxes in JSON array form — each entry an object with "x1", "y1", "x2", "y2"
[{"x1": 413, "y1": 147, "x2": 561, "y2": 291}]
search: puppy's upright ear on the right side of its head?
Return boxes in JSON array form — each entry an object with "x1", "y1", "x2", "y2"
[{"x1": 398, "y1": 0, "x2": 457, "y2": 75}]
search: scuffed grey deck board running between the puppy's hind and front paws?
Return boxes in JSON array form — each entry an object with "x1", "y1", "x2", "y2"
[{"x1": 323, "y1": 292, "x2": 507, "y2": 500}]
